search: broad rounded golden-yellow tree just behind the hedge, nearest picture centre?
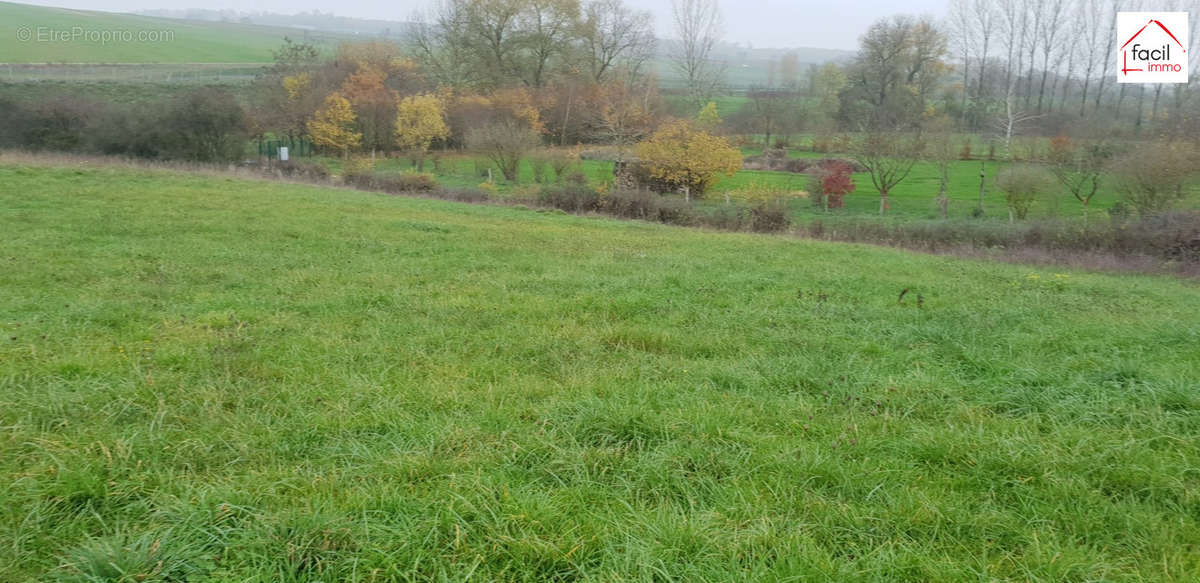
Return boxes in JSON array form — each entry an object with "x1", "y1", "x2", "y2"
[{"x1": 637, "y1": 121, "x2": 742, "y2": 199}]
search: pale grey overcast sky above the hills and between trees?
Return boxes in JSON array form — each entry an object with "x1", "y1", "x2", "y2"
[{"x1": 17, "y1": 0, "x2": 947, "y2": 49}]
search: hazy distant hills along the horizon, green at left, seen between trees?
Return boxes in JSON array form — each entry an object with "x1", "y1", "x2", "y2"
[{"x1": 0, "y1": 2, "x2": 851, "y2": 88}]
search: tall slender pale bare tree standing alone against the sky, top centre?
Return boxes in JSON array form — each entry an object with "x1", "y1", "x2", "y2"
[{"x1": 671, "y1": 0, "x2": 722, "y2": 98}]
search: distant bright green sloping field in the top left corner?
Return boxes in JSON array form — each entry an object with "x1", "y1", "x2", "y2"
[{"x1": 0, "y1": 2, "x2": 304, "y2": 63}]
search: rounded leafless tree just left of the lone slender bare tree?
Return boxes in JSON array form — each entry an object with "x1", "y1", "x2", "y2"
[{"x1": 581, "y1": 0, "x2": 654, "y2": 83}]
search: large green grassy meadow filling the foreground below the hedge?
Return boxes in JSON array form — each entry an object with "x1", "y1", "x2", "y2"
[{"x1": 0, "y1": 161, "x2": 1200, "y2": 582}]
